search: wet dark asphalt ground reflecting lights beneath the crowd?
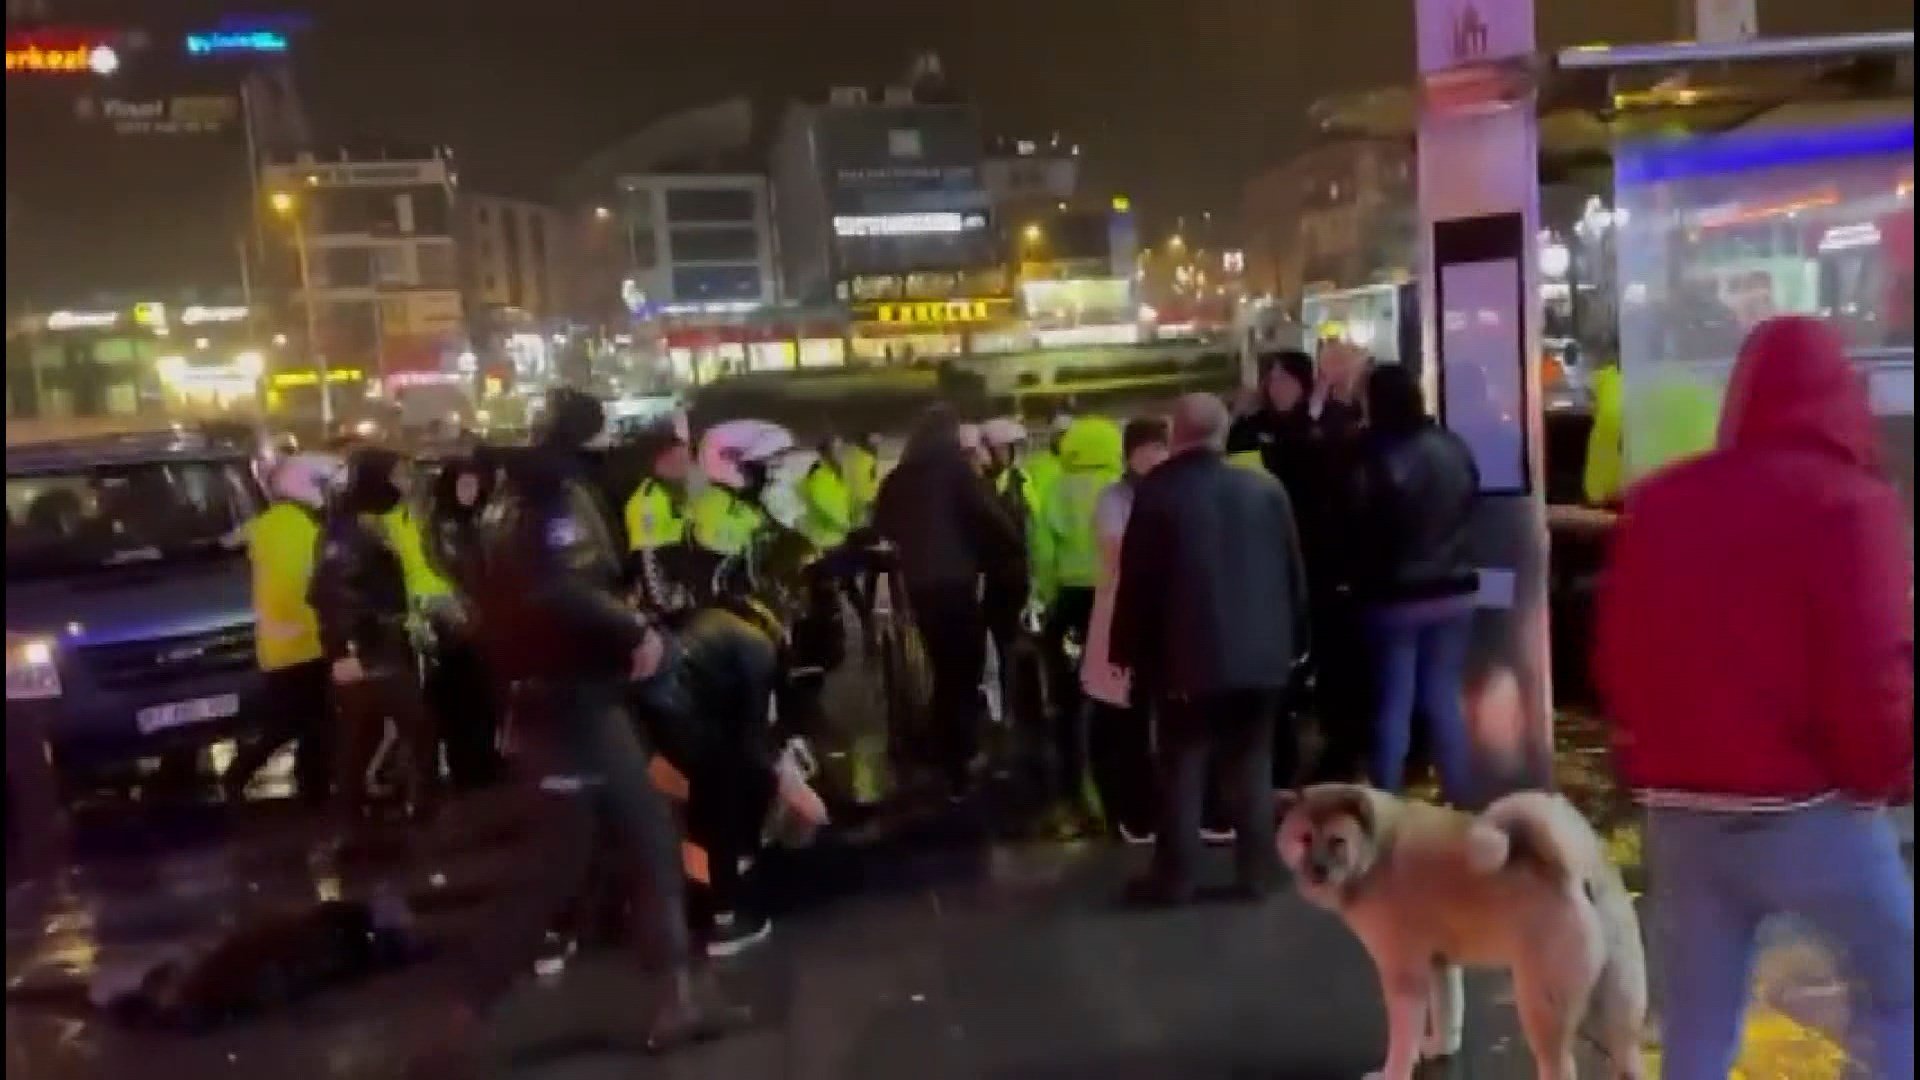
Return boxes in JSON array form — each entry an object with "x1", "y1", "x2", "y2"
[{"x1": 6, "y1": 719, "x2": 1896, "y2": 1080}]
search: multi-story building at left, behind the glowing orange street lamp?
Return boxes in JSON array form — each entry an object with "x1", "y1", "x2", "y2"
[{"x1": 261, "y1": 146, "x2": 472, "y2": 388}]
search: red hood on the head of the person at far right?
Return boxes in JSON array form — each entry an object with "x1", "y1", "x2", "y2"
[{"x1": 1718, "y1": 317, "x2": 1874, "y2": 467}]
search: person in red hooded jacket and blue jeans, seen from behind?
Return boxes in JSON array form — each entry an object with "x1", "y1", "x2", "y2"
[{"x1": 1596, "y1": 319, "x2": 1914, "y2": 1080}]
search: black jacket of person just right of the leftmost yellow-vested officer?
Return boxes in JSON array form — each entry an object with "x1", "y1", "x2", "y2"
[{"x1": 307, "y1": 509, "x2": 411, "y2": 667}]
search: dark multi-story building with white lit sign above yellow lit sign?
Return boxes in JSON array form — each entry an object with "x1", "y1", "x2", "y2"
[{"x1": 772, "y1": 85, "x2": 1018, "y2": 359}]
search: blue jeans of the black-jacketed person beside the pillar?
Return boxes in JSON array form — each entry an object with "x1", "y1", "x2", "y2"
[{"x1": 1367, "y1": 598, "x2": 1476, "y2": 805}]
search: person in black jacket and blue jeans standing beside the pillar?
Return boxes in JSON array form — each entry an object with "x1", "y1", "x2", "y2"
[{"x1": 1350, "y1": 363, "x2": 1480, "y2": 805}]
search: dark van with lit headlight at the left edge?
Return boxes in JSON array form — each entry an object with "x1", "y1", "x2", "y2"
[{"x1": 6, "y1": 432, "x2": 261, "y2": 780}]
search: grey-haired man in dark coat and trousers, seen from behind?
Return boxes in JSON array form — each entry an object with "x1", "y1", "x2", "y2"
[{"x1": 1110, "y1": 394, "x2": 1308, "y2": 903}]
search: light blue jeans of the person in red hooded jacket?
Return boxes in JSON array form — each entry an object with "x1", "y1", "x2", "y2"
[{"x1": 1647, "y1": 799, "x2": 1914, "y2": 1080}]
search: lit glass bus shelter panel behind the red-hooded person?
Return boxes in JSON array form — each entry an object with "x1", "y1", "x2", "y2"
[{"x1": 1611, "y1": 116, "x2": 1914, "y2": 490}]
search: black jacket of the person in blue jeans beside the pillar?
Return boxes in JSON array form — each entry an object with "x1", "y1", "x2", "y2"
[{"x1": 1350, "y1": 423, "x2": 1480, "y2": 603}]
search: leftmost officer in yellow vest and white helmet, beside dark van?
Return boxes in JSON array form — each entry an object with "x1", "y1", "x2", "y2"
[{"x1": 221, "y1": 454, "x2": 342, "y2": 805}]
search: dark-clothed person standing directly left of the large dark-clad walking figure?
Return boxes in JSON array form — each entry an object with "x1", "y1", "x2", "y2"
[{"x1": 426, "y1": 449, "x2": 501, "y2": 790}]
